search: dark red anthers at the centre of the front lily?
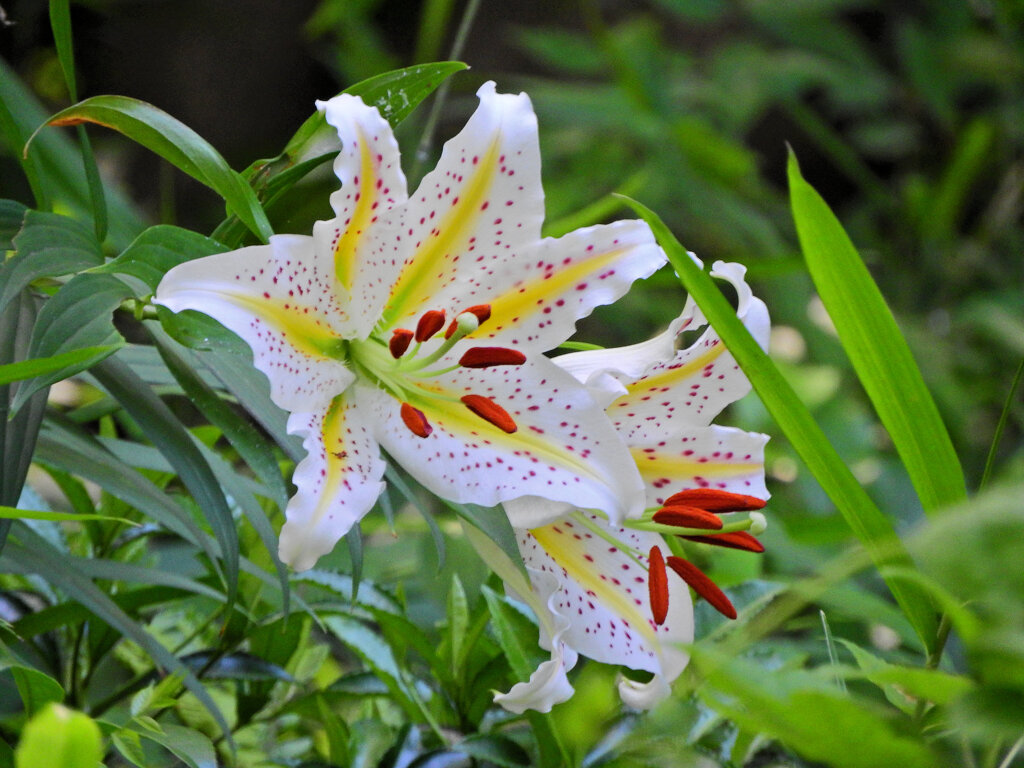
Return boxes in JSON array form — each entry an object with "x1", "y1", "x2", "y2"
[{"x1": 388, "y1": 304, "x2": 526, "y2": 437}]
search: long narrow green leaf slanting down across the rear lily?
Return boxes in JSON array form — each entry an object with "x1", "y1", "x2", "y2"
[{"x1": 627, "y1": 193, "x2": 937, "y2": 649}]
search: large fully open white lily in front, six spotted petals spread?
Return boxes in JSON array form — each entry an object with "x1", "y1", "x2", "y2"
[{"x1": 154, "y1": 83, "x2": 665, "y2": 570}]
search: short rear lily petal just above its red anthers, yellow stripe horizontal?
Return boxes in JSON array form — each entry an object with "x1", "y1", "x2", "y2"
[{"x1": 629, "y1": 424, "x2": 769, "y2": 507}]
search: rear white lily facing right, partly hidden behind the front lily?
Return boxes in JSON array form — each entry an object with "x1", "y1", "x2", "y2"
[{"x1": 485, "y1": 262, "x2": 769, "y2": 713}]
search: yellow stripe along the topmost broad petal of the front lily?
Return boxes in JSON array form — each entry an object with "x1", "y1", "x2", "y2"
[{"x1": 382, "y1": 138, "x2": 502, "y2": 328}]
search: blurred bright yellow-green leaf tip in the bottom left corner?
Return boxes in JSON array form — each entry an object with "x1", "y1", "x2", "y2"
[{"x1": 14, "y1": 705, "x2": 103, "y2": 768}]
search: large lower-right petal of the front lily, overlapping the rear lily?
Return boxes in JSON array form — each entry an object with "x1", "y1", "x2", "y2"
[{"x1": 378, "y1": 355, "x2": 643, "y2": 525}]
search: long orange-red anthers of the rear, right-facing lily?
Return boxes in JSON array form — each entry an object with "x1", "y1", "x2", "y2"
[{"x1": 647, "y1": 488, "x2": 765, "y2": 624}]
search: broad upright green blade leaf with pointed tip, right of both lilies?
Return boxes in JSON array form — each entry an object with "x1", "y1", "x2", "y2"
[{"x1": 788, "y1": 153, "x2": 967, "y2": 512}]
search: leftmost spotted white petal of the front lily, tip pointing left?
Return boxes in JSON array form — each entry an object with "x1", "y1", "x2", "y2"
[{"x1": 154, "y1": 234, "x2": 354, "y2": 412}]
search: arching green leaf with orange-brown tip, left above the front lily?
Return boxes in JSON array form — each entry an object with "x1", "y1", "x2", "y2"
[{"x1": 29, "y1": 96, "x2": 273, "y2": 243}]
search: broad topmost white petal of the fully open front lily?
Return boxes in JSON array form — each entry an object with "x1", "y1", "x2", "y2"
[{"x1": 368, "y1": 83, "x2": 544, "y2": 329}]
